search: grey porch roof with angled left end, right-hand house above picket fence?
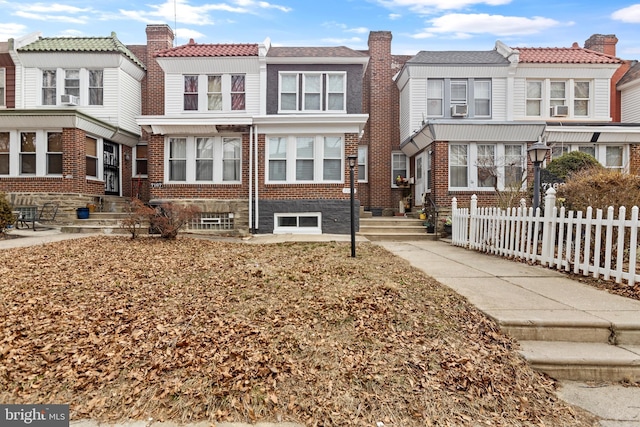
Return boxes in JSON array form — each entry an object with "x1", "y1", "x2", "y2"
[{"x1": 400, "y1": 120, "x2": 546, "y2": 156}]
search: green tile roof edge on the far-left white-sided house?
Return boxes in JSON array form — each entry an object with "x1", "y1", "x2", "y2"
[{"x1": 18, "y1": 32, "x2": 146, "y2": 69}]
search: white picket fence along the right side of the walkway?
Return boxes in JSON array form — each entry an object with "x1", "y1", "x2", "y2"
[{"x1": 451, "y1": 188, "x2": 640, "y2": 286}]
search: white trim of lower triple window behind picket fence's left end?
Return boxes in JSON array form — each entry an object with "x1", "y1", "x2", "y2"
[{"x1": 447, "y1": 142, "x2": 527, "y2": 192}]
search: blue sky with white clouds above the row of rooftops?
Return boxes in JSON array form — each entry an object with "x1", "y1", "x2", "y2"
[{"x1": 0, "y1": 0, "x2": 640, "y2": 59}]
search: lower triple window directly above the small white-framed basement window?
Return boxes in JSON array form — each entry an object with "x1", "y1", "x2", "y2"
[{"x1": 267, "y1": 135, "x2": 344, "y2": 183}]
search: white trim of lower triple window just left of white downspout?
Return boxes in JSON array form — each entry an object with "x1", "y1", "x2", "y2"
[{"x1": 164, "y1": 135, "x2": 242, "y2": 185}]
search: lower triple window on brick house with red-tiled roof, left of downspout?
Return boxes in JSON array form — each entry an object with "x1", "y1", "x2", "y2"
[{"x1": 165, "y1": 136, "x2": 242, "y2": 184}]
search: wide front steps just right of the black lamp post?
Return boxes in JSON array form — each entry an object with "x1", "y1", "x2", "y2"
[{"x1": 357, "y1": 216, "x2": 436, "y2": 241}]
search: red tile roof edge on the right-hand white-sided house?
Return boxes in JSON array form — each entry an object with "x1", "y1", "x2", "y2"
[{"x1": 513, "y1": 43, "x2": 622, "y2": 64}]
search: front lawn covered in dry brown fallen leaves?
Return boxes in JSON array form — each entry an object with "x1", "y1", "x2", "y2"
[{"x1": 0, "y1": 236, "x2": 593, "y2": 427}]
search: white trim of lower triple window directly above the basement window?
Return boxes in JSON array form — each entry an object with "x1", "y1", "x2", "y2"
[{"x1": 264, "y1": 134, "x2": 345, "y2": 184}]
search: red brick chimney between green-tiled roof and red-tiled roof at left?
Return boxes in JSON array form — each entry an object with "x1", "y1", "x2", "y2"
[{"x1": 142, "y1": 24, "x2": 173, "y2": 115}]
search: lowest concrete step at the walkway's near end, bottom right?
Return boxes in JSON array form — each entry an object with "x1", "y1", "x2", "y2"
[{"x1": 520, "y1": 341, "x2": 640, "y2": 382}]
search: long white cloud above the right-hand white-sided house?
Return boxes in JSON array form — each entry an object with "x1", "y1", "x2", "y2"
[{"x1": 412, "y1": 13, "x2": 560, "y2": 39}]
